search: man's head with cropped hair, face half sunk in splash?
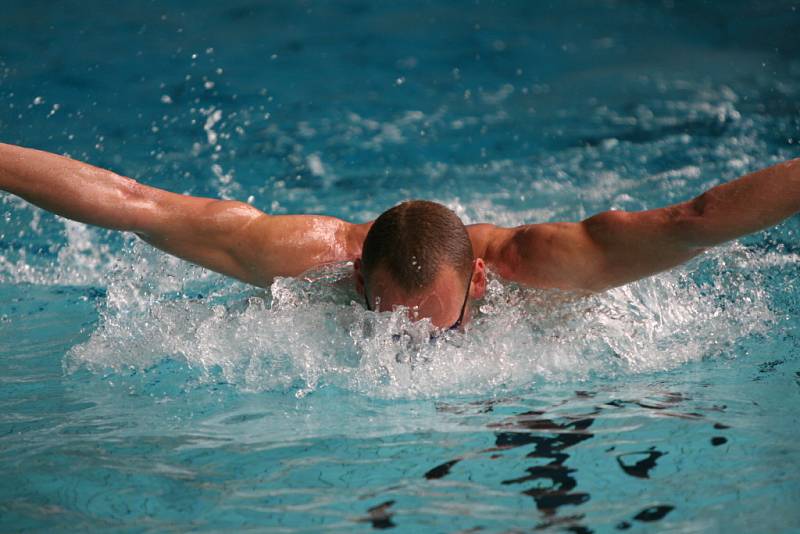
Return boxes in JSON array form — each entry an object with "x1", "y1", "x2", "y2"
[{"x1": 356, "y1": 200, "x2": 486, "y2": 328}]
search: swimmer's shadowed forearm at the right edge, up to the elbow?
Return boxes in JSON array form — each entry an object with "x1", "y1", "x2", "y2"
[{"x1": 682, "y1": 159, "x2": 800, "y2": 247}]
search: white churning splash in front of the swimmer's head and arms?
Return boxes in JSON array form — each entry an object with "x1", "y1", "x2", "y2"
[{"x1": 65, "y1": 237, "x2": 780, "y2": 398}]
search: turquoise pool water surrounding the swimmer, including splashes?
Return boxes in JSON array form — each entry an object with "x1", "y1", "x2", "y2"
[{"x1": 0, "y1": 1, "x2": 800, "y2": 532}]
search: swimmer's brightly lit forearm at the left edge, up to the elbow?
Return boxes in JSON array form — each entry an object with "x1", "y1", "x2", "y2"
[{"x1": 0, "y1": 143, "x2": 151, "y2": 231}]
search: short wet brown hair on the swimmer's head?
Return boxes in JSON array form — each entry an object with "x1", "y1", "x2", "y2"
[{"x1": 361, "y1": 200, "x2": 473, "y2": 293}]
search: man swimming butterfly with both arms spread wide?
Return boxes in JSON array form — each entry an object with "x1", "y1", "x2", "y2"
[{"x1": 0, "y1": 143, "x2": 800, "y2": 329}]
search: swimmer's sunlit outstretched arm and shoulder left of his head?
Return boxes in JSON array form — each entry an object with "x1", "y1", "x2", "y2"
[{"x1": 0, "y1": 143, "x2": 369, "y2": 287}]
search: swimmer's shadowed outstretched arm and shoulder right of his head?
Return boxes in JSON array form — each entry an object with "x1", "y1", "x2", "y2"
[{"x1": 469, "y1": 159, "x2": 800, "y2": 291}]
